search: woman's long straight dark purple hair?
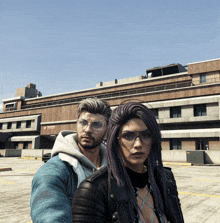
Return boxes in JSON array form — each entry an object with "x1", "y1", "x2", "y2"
[{"x1": 106, "y1": 102, "x2": 166, "y2": 218}]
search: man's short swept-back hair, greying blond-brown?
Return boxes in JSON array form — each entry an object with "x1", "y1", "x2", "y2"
[{"x1": 77, "y1": 97, "x2": 111, "y2": 123}]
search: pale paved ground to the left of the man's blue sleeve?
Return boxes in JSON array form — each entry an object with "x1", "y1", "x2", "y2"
[{"x1": 0, "y1": 158, "x2": 44, "y2": 223}]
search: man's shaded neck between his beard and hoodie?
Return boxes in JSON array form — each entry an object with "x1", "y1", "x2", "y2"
[{"x1": 79, "y1": 146, "x2": 101, "y2": 168}]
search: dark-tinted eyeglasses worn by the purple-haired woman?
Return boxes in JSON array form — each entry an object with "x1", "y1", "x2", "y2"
[{"x1": 118, "y1": 130, "x2": 151, "y2": 147}]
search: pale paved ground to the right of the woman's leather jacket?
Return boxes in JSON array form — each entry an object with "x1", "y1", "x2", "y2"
[{"x1": 166, "y1": 163, "x2": 220, "y2": 223}]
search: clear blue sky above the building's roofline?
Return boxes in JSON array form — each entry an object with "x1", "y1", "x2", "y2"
[{"x1": 0, "y1": 0, "x2": 220, "y2": 110}]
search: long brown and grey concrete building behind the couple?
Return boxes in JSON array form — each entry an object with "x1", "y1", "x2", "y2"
[{"x1": 0, "y1": 59, "x2": 220, "y2": 160}]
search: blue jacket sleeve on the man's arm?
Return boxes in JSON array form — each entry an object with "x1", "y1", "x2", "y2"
[{"x1": 30, "y1": 157, "x2": 77, "y2": 223}]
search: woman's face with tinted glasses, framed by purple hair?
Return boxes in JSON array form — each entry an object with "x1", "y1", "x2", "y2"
[{"x1": 118, "y1": 118, "x2": 152, "y2": 173}]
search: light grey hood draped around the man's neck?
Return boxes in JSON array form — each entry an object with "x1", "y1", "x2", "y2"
[{"x1": 51, "y1": 131, "x2": 106, "y2": 172}]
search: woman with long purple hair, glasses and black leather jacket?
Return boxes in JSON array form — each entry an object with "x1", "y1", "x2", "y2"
[{"x1": 72, "y1": 102, "x2": 184, "y2": 223}]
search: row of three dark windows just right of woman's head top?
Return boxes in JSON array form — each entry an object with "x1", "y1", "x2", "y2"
[{"x1": 152, "y1": 104, "x2": 207, "y2": 119}]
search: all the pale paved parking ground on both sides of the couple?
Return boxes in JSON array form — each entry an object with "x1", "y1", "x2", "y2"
[{"x1": 0, "y1": 158, "x2": 220, "y2": 223}]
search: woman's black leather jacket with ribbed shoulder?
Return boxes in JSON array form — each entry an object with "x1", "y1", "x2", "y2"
[{"x1": 72, "y1": 167, "x2": 184, "y2": 223}]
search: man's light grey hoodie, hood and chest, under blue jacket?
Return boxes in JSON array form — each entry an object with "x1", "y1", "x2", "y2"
[{"x1": 51, "y1": 131, "x2": 106, "y2": 187}]
